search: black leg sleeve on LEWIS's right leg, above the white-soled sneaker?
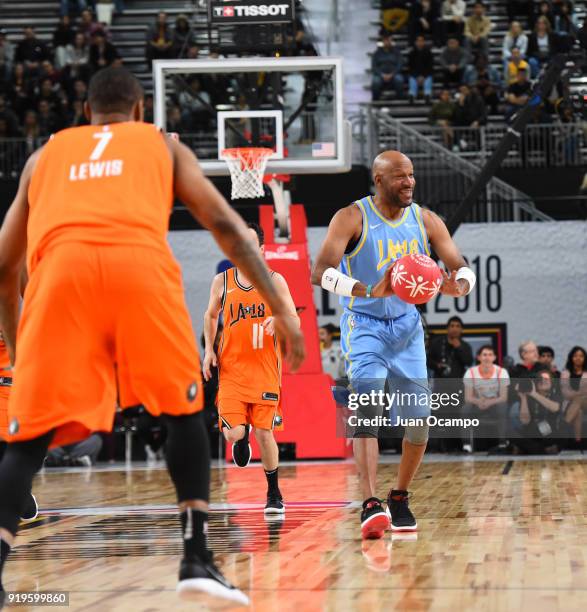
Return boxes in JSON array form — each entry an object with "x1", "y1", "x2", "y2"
[{"x1": 162, "y1": 412, "x2": 210, "y2": 502}]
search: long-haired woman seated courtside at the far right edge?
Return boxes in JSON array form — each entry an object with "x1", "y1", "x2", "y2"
[{"x1": 560, "y1": 346, "x2": 587, "y2": 443}]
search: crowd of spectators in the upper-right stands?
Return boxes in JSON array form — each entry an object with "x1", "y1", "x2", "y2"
[{"x1": 372, "y1": 0, "x2": 579, "y2": 147}]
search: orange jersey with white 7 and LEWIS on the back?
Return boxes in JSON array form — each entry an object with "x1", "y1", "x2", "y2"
[{"x1": 27, "y1": 121, "x2": 173, "y2": 274}]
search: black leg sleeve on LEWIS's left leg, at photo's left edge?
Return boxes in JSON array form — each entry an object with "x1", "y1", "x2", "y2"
[{"x1": 0, "y1": 432, "x2": 53, "y2": 534}]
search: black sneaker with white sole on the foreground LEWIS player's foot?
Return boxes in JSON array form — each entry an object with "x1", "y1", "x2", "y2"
[{"x1": 177, "y1": 553, "x2": 249, "y2": 606}]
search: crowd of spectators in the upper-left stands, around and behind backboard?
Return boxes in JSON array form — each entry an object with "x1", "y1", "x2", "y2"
[{"x1": 0, "y1": 6, "x2": 317, "y2": 154}]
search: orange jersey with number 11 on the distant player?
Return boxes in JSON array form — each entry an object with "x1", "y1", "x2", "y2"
[{"x1": 218, "y1": 268, "x2": 281, "y2": 405}]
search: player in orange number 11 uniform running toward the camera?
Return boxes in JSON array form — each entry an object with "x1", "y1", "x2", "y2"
[{"x1": 203, "y1": 223, "x2": 300, "y2": 514}]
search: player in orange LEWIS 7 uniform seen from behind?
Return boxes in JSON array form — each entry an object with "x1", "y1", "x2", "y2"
[{"x1": 0, "y1": 67, "x2": 304, "y2": 604}]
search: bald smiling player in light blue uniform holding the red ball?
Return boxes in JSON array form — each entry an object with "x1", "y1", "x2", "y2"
[{"x1": 312, "y1": 151, "x2": 475, "y2": 538}]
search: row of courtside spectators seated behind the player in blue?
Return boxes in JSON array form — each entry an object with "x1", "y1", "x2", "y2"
[{"x1": 320, "y1": 316, "x2": 587, "y2": 454}]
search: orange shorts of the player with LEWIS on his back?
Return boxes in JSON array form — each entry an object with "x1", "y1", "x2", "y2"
[{"x1": 8, "y1": 242, "x2": 204, "y2": 446}]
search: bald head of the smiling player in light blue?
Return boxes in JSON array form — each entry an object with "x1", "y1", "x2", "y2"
[{"x1": 372, "y1": 151, "x2": 416, "y2": 208}]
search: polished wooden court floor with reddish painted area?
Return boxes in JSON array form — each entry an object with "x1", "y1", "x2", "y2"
[{"x1": 5, "y1": 455, "x2": 587, "y2": 612}]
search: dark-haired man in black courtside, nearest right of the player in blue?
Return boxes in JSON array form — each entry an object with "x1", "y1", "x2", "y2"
[{"x1": 428, "y1": 316, "x2": 473, "y2": 379}]
